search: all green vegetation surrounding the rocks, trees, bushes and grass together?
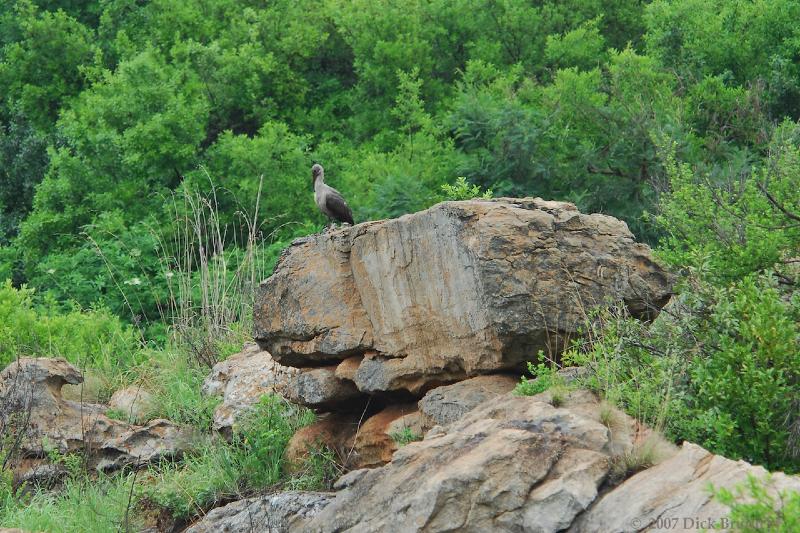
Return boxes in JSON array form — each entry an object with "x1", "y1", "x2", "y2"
[{"x1": 0, "y1": 0, "x2": 800, "y2": 530}]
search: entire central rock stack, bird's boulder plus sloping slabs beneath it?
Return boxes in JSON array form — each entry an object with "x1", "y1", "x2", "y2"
[{"x1": 192, "y1": 199, "x2": 800, "y2": 533}]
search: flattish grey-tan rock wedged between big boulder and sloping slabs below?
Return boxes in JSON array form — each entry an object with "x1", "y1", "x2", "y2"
[{"x1": 419, "y1": 375, "x2": 519, "y2": 427}]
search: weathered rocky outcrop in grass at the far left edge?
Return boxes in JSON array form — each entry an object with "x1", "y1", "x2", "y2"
[{"x1": 0, "y1": 358, "x2": 191, "y2": 481}]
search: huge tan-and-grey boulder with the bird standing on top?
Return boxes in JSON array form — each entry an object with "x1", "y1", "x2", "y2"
[{"x1": 254, "y1": 198, "x2": 671, "y2": 396}]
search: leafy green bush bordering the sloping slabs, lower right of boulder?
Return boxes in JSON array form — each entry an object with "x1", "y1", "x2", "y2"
[{"x1": 567, "y1": 276, "x2": 800, "y2": 471}]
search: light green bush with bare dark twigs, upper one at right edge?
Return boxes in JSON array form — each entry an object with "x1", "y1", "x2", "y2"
[{"x1": 657, "y1": 122, "x2": 800, "y2": 283}]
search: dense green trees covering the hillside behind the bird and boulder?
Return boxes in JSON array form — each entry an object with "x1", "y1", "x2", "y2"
[{"x1": 0, "y1": 0, "x2": 800, "y2": 328}]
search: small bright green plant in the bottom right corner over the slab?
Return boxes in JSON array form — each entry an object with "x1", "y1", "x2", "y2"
[{"x1": 710, "y1": 475, "x2": 800, "y2": 533}]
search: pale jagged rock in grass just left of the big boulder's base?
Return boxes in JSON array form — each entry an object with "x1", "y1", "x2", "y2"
[{"x1": 202, "y1": 343, "x2": 300, "y2": 433}]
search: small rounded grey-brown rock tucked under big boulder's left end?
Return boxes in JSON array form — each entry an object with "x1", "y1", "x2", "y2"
[{"x1": 284, "y1": 366, "x2": 364, "y2": 409}]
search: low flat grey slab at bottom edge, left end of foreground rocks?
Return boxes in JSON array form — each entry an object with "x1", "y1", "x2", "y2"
[{"x1": 186, "y1": 492, "x2": 333, "y2": 533}]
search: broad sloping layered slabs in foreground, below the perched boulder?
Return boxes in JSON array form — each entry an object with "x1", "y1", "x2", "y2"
[{"x1": 195, "y1": 391, "x2": 800, "y2": 533}]
